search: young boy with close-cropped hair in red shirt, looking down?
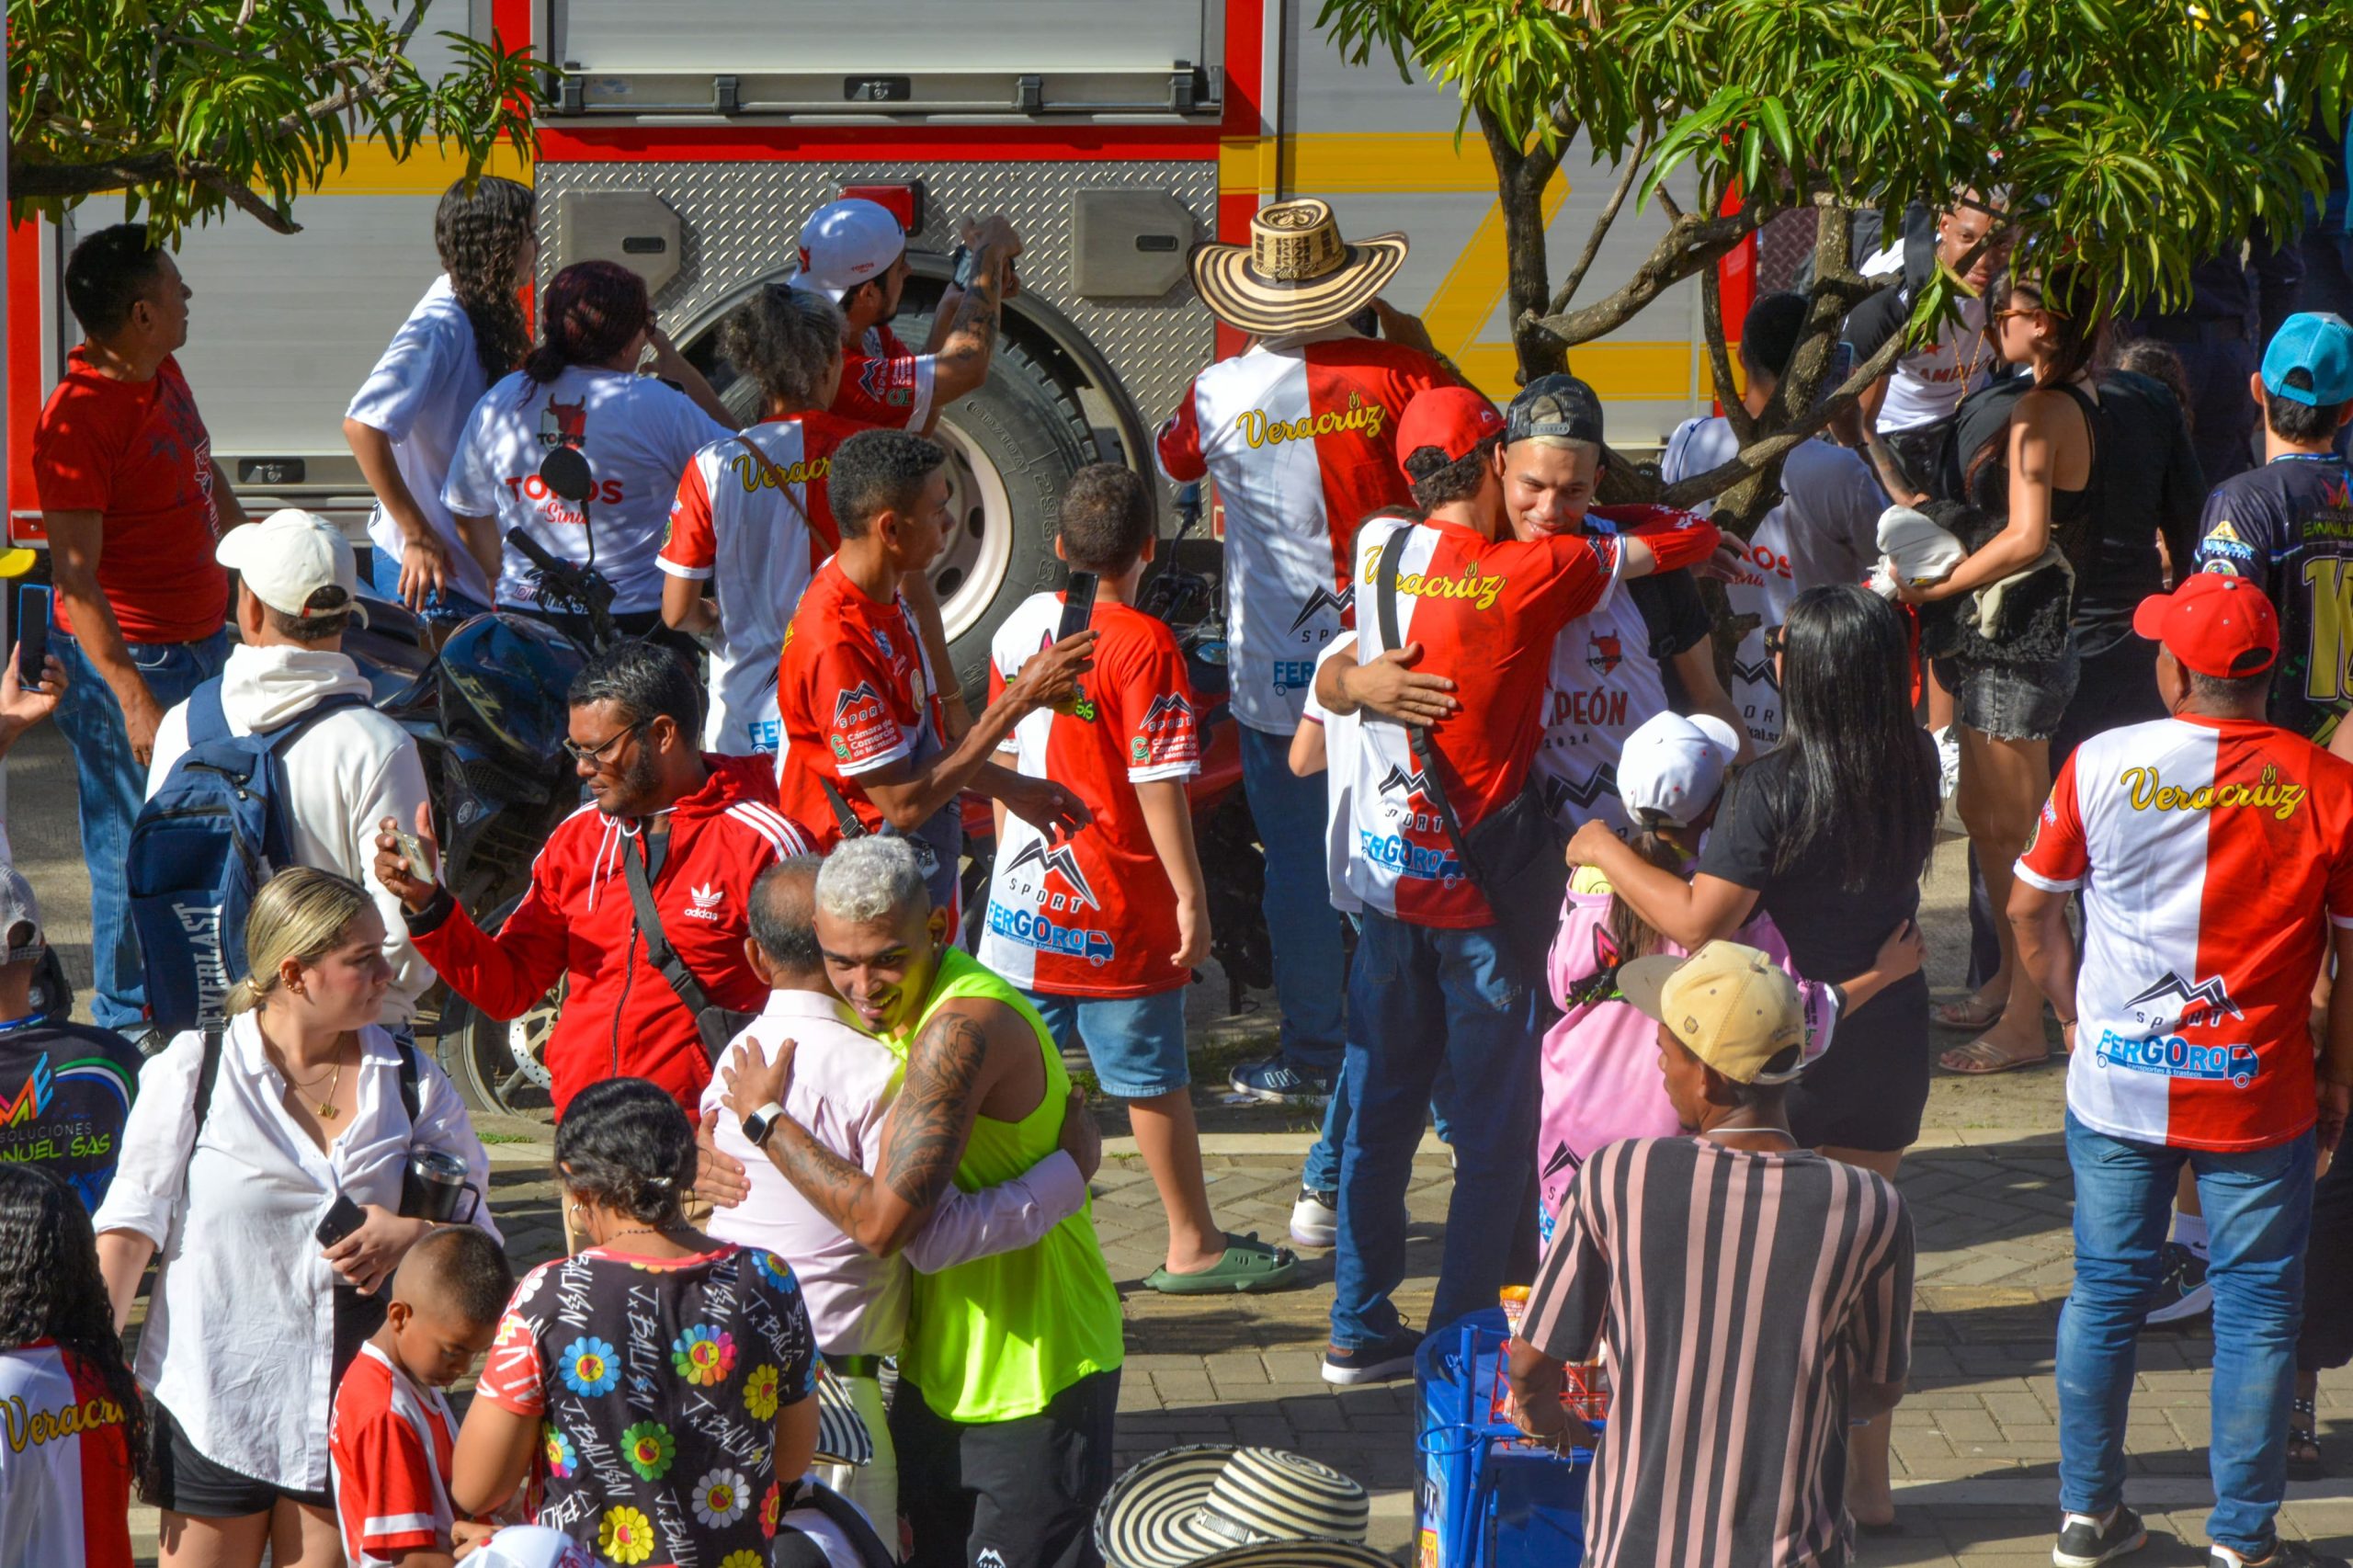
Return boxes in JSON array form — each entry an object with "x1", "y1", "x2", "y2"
[{"x1": 327, "y1": 1224, "x2": 516, "y2": 1568}]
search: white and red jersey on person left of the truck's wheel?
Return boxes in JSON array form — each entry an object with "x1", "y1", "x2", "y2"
[{"x1": 654, "y1": 410, "x2": 858, "y2": 756}]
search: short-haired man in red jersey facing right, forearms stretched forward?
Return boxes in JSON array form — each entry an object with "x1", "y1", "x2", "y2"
[{"x1": 777, "y1": 431, "x2": 1094, "y2": 930}]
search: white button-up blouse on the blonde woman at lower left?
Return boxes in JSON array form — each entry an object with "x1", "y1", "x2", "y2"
[{"x1": 92, "y1": 1012, "x2": 499, "y2": 1490}]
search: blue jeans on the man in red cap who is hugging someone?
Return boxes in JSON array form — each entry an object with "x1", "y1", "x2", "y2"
[{"x1": 1332, "y1": 909, "x2": 1541, "y2": 1349}]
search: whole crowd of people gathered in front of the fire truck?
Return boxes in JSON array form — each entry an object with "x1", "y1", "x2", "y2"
[{"x1": 0, "y1": 165, "x2": 2353, "y2": 1568}]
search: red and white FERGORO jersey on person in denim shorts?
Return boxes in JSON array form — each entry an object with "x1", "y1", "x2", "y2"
[{"x1": 976, "y1": 594, "x2": 1200, "y2": 996}]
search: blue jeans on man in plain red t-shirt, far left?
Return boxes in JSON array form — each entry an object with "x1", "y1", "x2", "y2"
[{"x1": 50, "y1": 629, "x2": 228, "y2": 1034}]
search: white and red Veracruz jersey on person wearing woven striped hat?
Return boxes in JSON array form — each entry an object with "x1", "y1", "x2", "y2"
[{"x1": 1158, "y1": 327, "x2": 1452, "y2": 734}]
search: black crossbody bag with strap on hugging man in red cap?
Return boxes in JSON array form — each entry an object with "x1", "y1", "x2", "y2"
[{"x1": 1377, "y1": 528, "x2": 1570, "y2": 996}]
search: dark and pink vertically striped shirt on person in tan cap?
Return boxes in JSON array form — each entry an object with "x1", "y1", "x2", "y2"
[{"x1": 1522, "y1": 1137, "x2": 1913, "y2": 1568}]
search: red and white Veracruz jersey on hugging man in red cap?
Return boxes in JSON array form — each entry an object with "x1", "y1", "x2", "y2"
[{"x1": 1348, "y1": 520, "x2": 1619, "y2": 927}]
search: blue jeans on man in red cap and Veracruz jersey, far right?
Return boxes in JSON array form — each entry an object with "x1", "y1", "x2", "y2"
[{"x1": 2059, "y1": 1114, "x2": 2313, "y2": 1556}]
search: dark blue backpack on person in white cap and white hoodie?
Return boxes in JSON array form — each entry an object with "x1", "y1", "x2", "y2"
[{"x1": 125, "y1": 678, "x2": 367, "y2": 1036}]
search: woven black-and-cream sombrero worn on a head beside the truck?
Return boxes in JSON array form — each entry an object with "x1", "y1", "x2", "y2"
[{"x1": 1186, "y1": 196, "x2": 1404, "y2": 336}]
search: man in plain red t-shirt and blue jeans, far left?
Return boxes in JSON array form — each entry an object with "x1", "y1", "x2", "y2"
[{"x1": 33, "y1": 223, "x2": 244, "y2": 1034}]
